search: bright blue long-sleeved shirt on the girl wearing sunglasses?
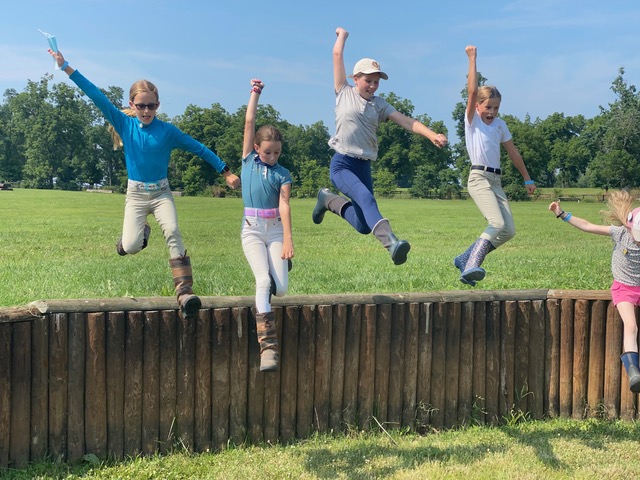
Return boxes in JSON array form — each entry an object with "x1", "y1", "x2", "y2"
[{"x1": 69, "y1": 70, "x2": 226, "y2": 182}]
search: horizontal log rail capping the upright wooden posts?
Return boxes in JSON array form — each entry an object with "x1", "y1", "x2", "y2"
[{"x1": 0, "y1": 289, "x2": 611, "y2": 323}]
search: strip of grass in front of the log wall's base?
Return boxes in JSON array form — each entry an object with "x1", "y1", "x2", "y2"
[{"x1": 0, "y1": 419, "x2": 640, "y2": 480}]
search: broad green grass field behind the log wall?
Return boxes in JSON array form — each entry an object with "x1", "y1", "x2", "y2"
[{"x1": 0, "y1": 189, "x2": 611, "y2": 307}]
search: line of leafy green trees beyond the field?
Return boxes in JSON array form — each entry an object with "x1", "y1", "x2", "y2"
[{"x1": 0, "y1": 68, "x2": 640, "y2": 200}]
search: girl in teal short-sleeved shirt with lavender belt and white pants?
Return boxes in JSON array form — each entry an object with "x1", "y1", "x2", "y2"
[{"x1": 240, "y1": 80, "x2": 293, "y2": 372}]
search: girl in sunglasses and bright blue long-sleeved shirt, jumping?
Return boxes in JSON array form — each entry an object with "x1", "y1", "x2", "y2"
[{"x1": 49, "y1": 50, "x2": 240, "y2": 317}]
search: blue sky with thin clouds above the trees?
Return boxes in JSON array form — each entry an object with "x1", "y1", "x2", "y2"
[{"x1": 0, "y1": 0, "x2": 640, "y2": 140}]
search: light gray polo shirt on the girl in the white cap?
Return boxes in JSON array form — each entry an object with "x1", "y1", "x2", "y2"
[{"x1": 329, "y1": 81, "x2": 396, "y2": 160}]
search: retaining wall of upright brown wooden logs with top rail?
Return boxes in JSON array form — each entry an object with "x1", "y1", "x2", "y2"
[{"x1": 0, "y1": 290, "x2": 638, "y2": 468}]
